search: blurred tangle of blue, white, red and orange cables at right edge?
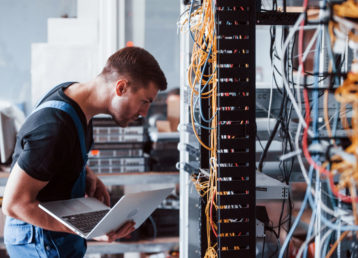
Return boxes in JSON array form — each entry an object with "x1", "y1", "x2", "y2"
[{"x1": 279, "y1": 0, "x2": 358, "y2": 257}]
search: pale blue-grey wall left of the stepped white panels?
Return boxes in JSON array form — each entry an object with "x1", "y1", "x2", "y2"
[{"x1": 0, "y1": 0, "x2": 76, "y2": 113}]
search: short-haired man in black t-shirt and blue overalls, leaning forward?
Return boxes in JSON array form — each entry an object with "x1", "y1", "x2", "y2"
[{"x1": 2, "y1": 47, "x2": 167, "y2": 257}]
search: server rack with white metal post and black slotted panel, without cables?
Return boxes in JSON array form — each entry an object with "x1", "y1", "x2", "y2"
[{"x1": 179, "y1": 0, "x2": 256, "y2": 258}]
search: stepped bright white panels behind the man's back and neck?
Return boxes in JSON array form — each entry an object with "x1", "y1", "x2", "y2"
[{"x1": 31, "y1": 0, "x2": 102, "y2": 106}]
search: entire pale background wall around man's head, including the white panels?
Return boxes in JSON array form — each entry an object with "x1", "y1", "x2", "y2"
[{"x1": 0, "y1": 0, "x2": 179, "y2": 113}]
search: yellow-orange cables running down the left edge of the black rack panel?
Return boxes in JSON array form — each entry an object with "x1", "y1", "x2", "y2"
[{"x1": 184, "y1": 0, "x2": 218, "y2": 255}]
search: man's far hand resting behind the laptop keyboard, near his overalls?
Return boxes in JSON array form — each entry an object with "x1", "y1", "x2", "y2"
[{"x1": 86, "y1": 166, "x2": 110, "y2": 206}]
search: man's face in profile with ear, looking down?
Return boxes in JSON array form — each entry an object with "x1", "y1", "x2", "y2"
[{"x1": 108, "y1": 80, "x2": 158, "y2": 127}]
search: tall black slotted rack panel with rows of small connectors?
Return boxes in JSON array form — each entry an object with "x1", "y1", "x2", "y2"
[{"x1": 216, "y1": 0, "x2": 256, "y2": 258}]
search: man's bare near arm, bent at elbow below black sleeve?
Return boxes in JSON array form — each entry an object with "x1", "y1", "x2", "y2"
[{"x1": 2, "y1": 163, "x2": 73, "y2": 233}]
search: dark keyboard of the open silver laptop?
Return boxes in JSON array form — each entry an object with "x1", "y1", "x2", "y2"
[{"x1": 62, "y1": 210, "x2": 109, "y2": 233}]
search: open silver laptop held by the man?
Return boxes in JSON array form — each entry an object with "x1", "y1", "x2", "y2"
[{"x1": 39, "y1": 188, "x2": 173, "y2": 239}]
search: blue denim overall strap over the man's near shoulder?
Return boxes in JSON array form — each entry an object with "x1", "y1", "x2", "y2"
[{"x1": 31, "y1": 100, "x2": 88, "y2": 198}]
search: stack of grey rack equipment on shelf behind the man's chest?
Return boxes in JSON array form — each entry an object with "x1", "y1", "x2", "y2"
[{"x1": 87, "y1": 116, "x2": 148, "y2": 173}]
